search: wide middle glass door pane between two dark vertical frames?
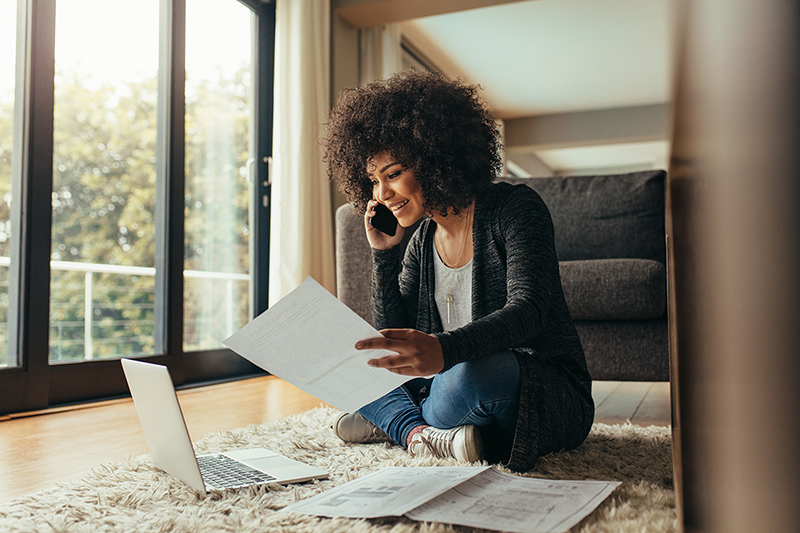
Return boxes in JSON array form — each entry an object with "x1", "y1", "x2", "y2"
[{"x1": 50, "y1": 0, "x2": 159, "y2": 363}]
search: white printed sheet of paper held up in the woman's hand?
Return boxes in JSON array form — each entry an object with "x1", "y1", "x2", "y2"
[{"x1": 223, "y1": 277, "x2": 411, "y2": 413}]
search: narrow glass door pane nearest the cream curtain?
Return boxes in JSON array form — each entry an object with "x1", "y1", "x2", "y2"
[{"x1": 183, "y1": 0, "x2": 254, "y2": 351}]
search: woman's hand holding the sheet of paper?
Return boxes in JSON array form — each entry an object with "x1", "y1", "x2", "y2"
[{"x1": 356, "y1": 329, "x2": 444, "y2": 376}]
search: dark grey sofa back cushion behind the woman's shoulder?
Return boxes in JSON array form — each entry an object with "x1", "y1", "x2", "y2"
[{"x1": 501, "y1": 170, "x2": 666, "y2": 264}]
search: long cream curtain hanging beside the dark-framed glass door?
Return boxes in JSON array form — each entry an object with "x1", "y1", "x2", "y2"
[{"x1": 269, "y1": 0, "x2": 336, "y2": 305}]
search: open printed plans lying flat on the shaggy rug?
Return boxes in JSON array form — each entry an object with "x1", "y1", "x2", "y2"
[{"x1": 285, "y1": 467, "x2": 620, "y2": 533}]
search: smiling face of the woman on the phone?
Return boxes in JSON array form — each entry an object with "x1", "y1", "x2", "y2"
[{"x1": 367, "y1": 152, "x2": 425, "y2": 228}]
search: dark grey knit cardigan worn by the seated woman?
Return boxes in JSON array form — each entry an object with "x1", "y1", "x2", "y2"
[{"x1": 372, "y1": 183, "x2": 594, "y2": 471}]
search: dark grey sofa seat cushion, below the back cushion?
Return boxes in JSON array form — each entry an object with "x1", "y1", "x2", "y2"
[{"x1": 559, "y1": 259, "x2": 667, "y2": 320}]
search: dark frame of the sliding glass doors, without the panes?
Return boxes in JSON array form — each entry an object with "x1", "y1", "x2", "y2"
[{"x1": 0, "y1": 0, "x2": 275, "y2": 413}]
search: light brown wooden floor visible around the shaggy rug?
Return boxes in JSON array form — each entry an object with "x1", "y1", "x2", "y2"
[{"x1": 0, "y1": 376, "x2": 671, "y2": 503}]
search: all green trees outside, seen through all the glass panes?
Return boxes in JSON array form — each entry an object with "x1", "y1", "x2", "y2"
[{"x1": 0, "y1": 63, "x2": 250, "y2": 365}]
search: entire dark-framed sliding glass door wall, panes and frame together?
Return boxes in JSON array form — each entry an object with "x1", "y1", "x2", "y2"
[{"x1": 0, "y1": 0, "x2": 275, "y2": 414}]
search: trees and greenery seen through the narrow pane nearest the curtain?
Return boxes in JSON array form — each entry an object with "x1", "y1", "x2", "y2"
[{"x1": 184, "y1": 67, "x2": 250, "y2": 350}]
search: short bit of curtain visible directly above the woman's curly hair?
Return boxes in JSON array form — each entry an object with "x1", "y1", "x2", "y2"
[{"x1": 358, "y1": 24, "x2": 403, "y2": 85}]
